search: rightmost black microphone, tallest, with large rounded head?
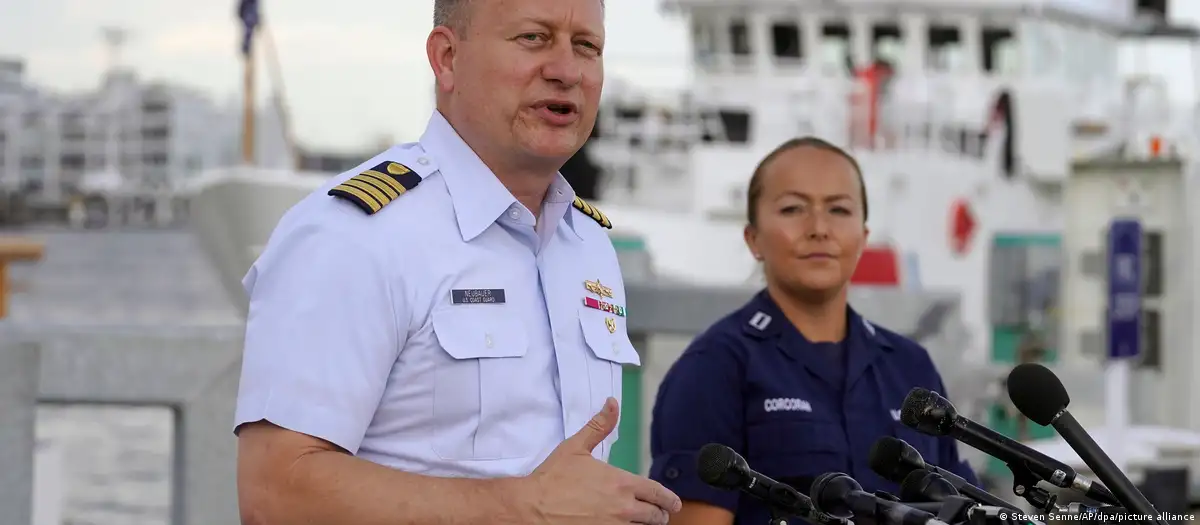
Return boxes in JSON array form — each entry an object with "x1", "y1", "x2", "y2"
[{"x1": 1007, "y1": 363, "x2": 1163, "y2": 523}]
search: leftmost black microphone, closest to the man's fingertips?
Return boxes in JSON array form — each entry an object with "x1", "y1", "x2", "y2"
[{"x1": 696, "y1": 443, "x2": 847, "y2": 525}]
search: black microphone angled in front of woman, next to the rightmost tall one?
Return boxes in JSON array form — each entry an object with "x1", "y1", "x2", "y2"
[{"x1": 900, "y1": 387, "x2": 1117, "y2": 507}]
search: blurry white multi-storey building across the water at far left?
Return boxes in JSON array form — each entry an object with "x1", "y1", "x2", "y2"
[{"x1": 0, "y1": 60, "x2": 289, "y2": 200}]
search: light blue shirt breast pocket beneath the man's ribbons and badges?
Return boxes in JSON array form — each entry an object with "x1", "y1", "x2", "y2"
[{"x1": 580, "y1": 308, "x2": 642, "y2": 458}]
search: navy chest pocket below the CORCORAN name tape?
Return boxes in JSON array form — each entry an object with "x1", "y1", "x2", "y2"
[{"x1": 746, "y1": 414, "x2": 850, "y2": 494}]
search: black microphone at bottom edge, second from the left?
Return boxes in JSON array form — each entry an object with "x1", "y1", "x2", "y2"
[{"x1": 810, "y1": 472, "x2": 947, "y2": 525}]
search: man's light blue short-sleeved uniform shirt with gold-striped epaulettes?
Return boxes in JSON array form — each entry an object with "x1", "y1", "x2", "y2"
[{"x1": 235, "y1": 113, "x2": 641, "y2": 477}]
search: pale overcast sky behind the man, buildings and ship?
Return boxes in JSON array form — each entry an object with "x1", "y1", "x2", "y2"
[{"x1": 0, "y1": 0, "x2": 1200, "y2": 151}]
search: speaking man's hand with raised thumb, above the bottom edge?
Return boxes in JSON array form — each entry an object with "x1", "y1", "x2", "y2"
[{"x1": 528, "y1": 398, "x2": 682, "y2": 525}]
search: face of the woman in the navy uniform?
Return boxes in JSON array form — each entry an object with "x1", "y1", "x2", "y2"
[{"x1": 745, "y1": 146, "x2": 868, "y2": 296}]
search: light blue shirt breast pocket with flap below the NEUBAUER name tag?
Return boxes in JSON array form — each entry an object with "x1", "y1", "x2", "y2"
[{"x1": 431, "y1": 304, "x2": 530, "y2": 460}]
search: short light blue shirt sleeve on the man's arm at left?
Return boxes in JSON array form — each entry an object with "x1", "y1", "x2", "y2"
[{"x1": 234, "y1": 216, "x2": 409, "y2": 454}]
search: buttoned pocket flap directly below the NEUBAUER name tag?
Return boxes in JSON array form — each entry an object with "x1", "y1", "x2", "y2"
[{"x1": 432, "y1": 304, "x2": 529, "y2": 360}]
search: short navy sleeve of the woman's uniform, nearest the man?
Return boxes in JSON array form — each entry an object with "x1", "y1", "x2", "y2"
[{"x1": 650, "y1": 336, "x2": 745, "y2": 512}]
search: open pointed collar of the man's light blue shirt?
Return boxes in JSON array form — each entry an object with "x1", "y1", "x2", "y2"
[{"x1": 420, "y1": 110, "x2": 578, "y2": 241}]
